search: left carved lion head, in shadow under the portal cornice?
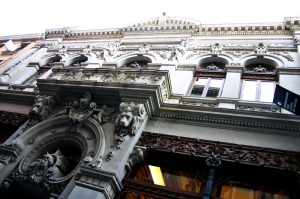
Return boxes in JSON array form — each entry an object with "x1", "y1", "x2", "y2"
[{"x1": 29, "y1": 95, "x2": 57, "y2": 126}]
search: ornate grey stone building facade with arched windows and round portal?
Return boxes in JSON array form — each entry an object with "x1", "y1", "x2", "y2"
[{"x1": 0, "y1": 16, "x2": 300, "y2": 199}]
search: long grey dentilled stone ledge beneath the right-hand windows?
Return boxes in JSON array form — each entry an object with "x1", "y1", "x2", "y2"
[{"x1": 157, "y1": 100, "x2": 300, "y2": 137}]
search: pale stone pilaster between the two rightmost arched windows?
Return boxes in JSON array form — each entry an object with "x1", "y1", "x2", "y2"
[{"x1": 218, "y1": 64, "x2": 243, "y2": 109}]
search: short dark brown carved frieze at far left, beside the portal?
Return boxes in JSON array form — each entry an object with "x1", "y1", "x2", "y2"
[{"x1": 0, "y1": 111, "x2": 29, "y2": 126}]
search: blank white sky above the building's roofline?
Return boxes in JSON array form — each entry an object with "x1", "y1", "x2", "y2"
[{"x1": 0, "y1": 0, "x2": 300, "y2": 36}]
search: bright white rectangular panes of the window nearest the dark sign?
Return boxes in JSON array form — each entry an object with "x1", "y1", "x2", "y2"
[{"x1": 240, "y1": 80, "x2": 276, "y2": 102}]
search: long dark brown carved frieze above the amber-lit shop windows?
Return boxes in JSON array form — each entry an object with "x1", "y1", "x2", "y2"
[{"x1": 137, "y1": 132, "x2": 300, "y2": 172}]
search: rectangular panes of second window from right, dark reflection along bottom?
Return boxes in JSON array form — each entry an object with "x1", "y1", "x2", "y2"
[{"x1": 190, "y1": 78, "x2": 224, "y2": 97}]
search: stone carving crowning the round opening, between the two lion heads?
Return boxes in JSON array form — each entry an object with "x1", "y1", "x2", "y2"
[{"x1": 53, "y1": 92, "x2": 106, "y2": 132}]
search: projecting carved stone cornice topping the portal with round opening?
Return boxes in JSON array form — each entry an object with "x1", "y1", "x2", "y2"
[{"x1": 37, "y1": 68, "x2": 172, "y2": 115}]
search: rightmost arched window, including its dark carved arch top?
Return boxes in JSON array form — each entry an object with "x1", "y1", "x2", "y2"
[{"x1": 240, "y1": 62, "x2": 277, "y2": 102}]
